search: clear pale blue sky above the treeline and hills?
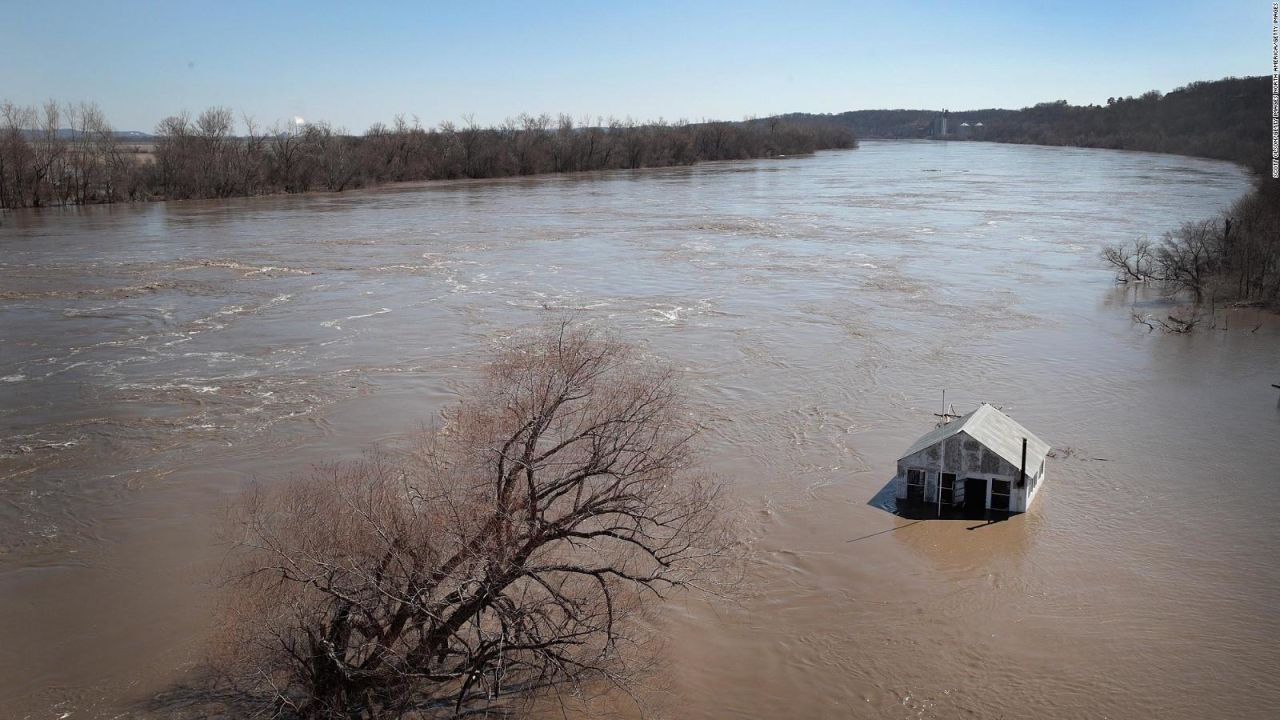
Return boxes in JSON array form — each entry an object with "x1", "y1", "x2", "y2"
[{"x1": 0, "y1": 0, "x2": 1271, "y2": 132}]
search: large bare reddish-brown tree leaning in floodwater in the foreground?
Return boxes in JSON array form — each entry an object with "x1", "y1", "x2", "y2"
[{"x1": 216, "y1": 323, "x2": 732, "y2": 720}]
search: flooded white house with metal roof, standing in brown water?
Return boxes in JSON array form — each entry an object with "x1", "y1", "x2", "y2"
[{"x1": 893, "y1": 404, "x2": 1050, "y2": 514}]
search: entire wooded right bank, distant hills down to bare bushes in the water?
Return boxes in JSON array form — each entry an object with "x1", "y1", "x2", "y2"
[{"x1": 783, "y1": 76, "x2": 1280, "y2": 308}]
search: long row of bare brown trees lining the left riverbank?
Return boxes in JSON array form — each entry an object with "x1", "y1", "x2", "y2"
[{"x1": 0, "y1": 102, "x2": 858, "y2": 208}]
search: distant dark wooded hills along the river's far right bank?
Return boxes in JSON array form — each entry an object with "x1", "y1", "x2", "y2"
[{"x1": 783, "y1": 76, "x2": 1271, "y2": 174}]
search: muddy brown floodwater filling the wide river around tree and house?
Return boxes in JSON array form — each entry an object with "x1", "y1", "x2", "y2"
[{"x1": 0, "y1": 137, "x2": 1280, "y2": 717}]
